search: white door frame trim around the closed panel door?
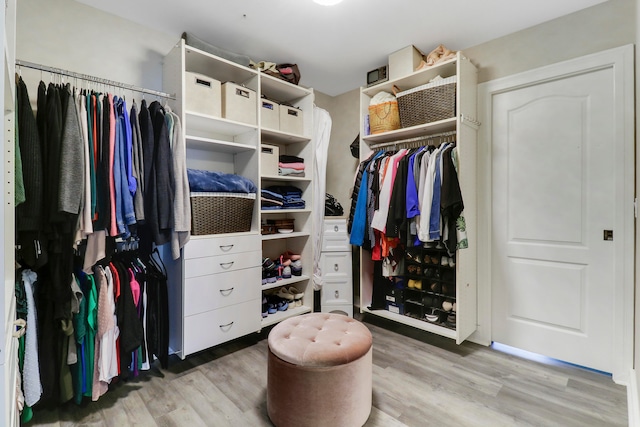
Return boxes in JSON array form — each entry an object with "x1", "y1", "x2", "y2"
[{"x1": 470, "y1": 44, "x2": 636, "y2": 385}]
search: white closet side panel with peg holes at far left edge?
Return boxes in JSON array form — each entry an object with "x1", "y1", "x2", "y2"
[{"x1": 0, "y1": 0, "x2": 19, "y2": 426}]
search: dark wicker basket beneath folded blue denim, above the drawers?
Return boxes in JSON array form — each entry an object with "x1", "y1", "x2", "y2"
[{"x1": 190, "y1": 193, "x2": 256, "y2": 236}]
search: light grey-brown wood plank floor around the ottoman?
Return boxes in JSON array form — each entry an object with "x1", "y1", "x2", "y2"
[{"x1": 28, "y1": 315, "x2": 628, "y2": 427}]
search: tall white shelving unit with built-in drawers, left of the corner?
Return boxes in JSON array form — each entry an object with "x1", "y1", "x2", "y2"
[{"x1": 163, "y1": 40, "x2": 313, "y2": 358}]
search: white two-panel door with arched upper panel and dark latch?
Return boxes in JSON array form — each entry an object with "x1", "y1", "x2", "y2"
[{"x1": 490, "y1": 48, "x2": 633, "y2": 380}]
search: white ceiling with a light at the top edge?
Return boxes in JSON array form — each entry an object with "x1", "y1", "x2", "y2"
[{"x1": 79, "y1": 0, "x2": 604, "y2": 96}]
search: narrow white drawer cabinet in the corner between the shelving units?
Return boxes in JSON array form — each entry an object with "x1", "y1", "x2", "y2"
[{"x1": 320, "y1": 218, "x2": 353, "y2": 317}]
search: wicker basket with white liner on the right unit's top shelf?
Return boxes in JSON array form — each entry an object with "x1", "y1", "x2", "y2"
[{"x1": 396, "y1": 76, "x2": 457, "y2": 128}]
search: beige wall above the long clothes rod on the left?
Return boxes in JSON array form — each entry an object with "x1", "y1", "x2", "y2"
[{"x1": 16, "y1": 0, "x2": 180, "y2": 98}]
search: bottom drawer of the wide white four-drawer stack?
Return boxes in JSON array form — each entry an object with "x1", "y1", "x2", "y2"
[{"x1": 183, "y1": 299, "x2": 262, "y2": 356}]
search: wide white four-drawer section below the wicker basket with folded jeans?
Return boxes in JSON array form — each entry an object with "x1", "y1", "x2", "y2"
[{"x1": 167, "y1": 234, "x2": 261, "y2": 358}]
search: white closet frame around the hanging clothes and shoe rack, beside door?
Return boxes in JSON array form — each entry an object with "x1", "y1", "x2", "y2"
[{"x1": 360, "y1": 52, "x2": 478, "y2": 344}]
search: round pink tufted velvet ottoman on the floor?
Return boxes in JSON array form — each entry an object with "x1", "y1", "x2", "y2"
[{"x1": 267, "y1": 313, "x2": 373, "y2": 427}]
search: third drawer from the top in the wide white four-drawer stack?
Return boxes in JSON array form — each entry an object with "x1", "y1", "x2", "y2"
[{"x1": 184, "y1": 267, "x2": 261, "y2": 316}]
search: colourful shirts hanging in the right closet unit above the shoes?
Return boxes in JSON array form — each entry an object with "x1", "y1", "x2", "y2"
[{"x1": 350, "y1": 143, "x2": 466, "y2": 262}]
